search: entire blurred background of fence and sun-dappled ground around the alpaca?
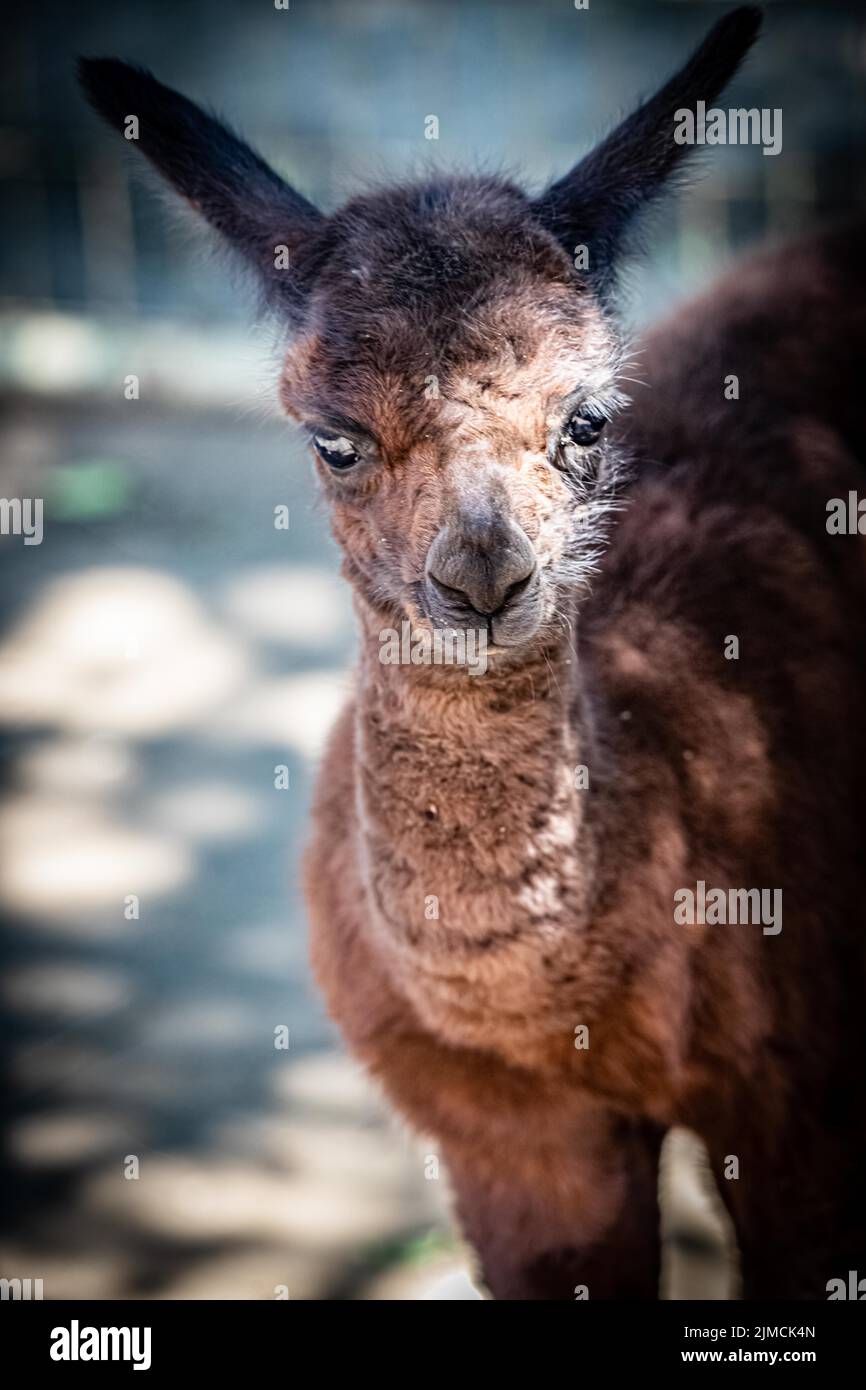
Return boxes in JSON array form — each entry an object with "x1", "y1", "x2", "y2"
[{"x1": 0, "y1": 0, "x2": 866, "y2": 1300}]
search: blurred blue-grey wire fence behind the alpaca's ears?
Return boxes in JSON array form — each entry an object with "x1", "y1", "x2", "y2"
[{"x1": 0, "y1": 0, "x2": 866, "y2": 333}]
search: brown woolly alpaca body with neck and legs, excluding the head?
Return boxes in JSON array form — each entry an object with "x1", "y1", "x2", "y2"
[{"x1": 307, "y1": 236, "x2": 866, "y2": 1297}]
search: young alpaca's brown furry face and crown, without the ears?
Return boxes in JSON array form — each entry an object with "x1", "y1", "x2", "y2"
[{"x1": 281, "y1": 179, "x2": 624, "y2": 648}]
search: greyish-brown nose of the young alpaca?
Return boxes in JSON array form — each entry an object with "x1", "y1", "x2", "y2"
[{"x1": 427, "y1": 512, "x2": 537, "y2": 617}]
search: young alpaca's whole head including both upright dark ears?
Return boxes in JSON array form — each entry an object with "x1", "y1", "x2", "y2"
[{"x1": 82, "y1": 8, "x2": 759, "y2": 659}]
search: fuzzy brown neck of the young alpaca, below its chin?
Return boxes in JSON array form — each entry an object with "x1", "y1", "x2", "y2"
[{"x1": 350, "y1": 600, "x2": 592, "y2": 1056}]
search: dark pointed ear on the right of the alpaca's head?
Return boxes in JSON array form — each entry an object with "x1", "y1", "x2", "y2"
[{"x1": 534, "y1": 6, "x2": 762, "y2": 288}]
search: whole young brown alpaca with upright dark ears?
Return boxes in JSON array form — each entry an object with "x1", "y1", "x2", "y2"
[{"x1": 82, "y1": 8, "x2": 866, "y2": 1300}]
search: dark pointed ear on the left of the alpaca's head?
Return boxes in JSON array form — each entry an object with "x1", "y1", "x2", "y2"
[{"x1": 78, "y1": 58, "x2": 325, "y2": 309}]
